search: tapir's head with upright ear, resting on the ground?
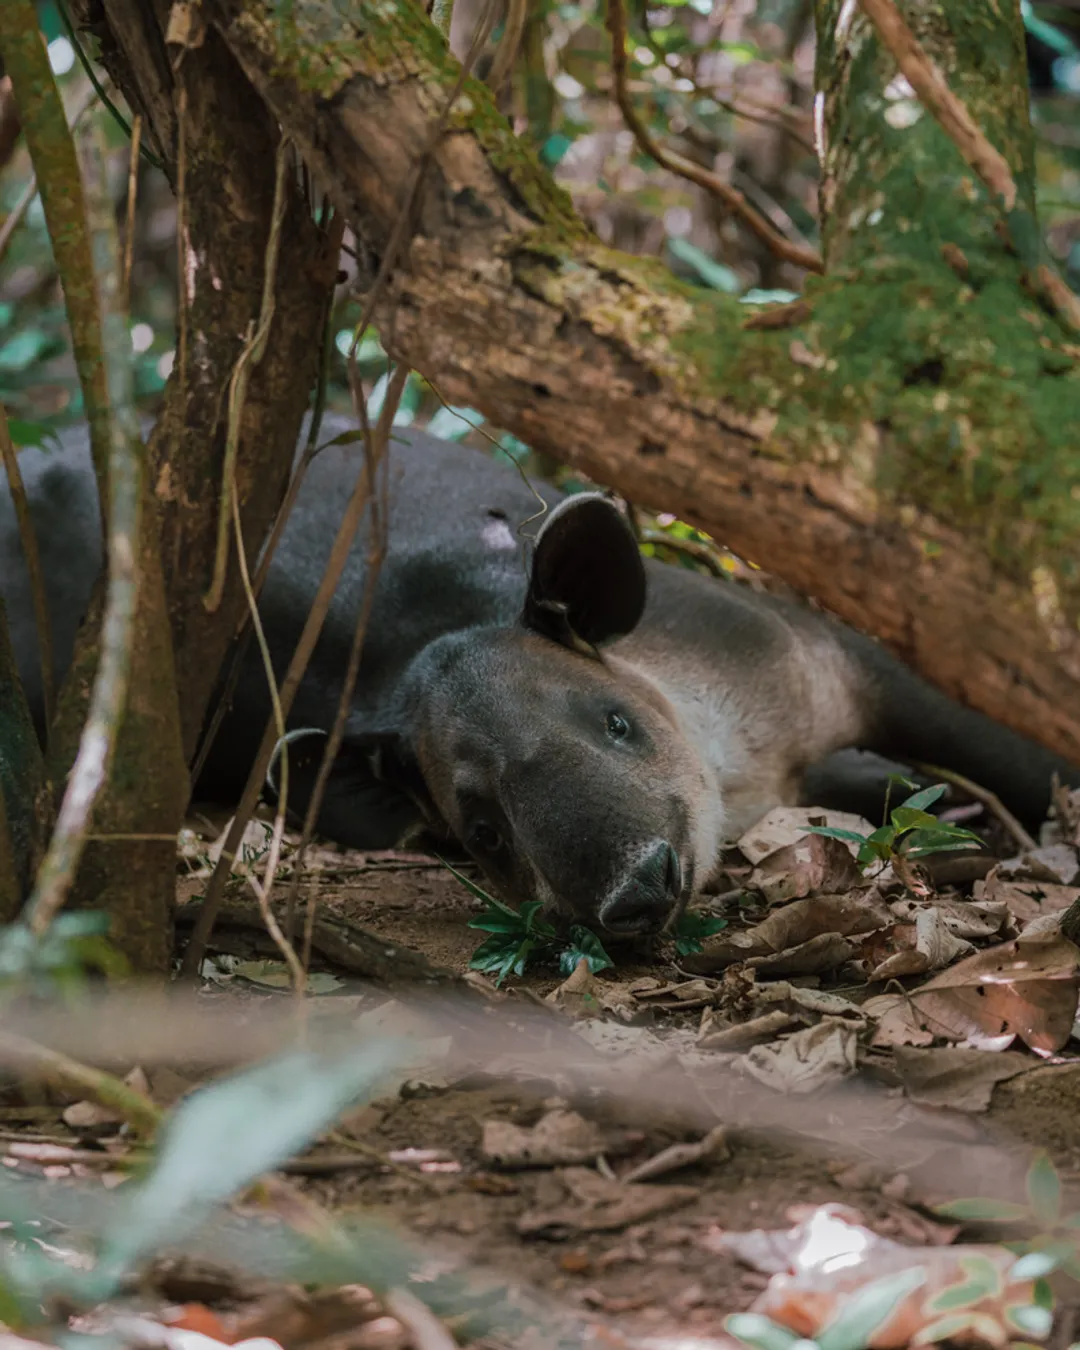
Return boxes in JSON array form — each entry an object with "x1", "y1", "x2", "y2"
[{"x1": 295, "y1": 494, "x2": 720, "y2": 934}]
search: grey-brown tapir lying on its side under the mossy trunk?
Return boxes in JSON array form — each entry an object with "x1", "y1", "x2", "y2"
[{"x1": 0, "y1": 420, "x2": 1080, "y2": 936}]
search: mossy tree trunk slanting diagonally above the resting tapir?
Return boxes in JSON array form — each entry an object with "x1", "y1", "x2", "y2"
[{"x1": 204, "y1": 0, "x2": 1080, "y2": 763}]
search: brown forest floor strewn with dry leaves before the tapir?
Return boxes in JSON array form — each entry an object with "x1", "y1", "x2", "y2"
[{"x1": 4, "y1": 793, "x2": 1080, "y2": 1350}]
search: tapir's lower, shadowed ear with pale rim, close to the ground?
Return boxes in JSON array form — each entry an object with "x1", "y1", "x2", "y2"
[{"x1": 266, "y1": 726, "x2": 433, "y2": 849}]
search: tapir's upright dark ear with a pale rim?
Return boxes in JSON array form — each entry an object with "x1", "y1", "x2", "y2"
[{"x1": 524, "y1": 493, "x2": 645, "y2": 651}]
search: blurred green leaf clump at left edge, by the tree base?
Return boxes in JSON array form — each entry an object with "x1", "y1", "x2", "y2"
[{"x1": 0, "y1": 910, "x2": 128, "y2": 995}]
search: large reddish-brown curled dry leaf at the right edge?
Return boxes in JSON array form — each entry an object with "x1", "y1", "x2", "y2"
[{"x1": 864, "y1": 933, "x2": 1080, "y2": 1054}]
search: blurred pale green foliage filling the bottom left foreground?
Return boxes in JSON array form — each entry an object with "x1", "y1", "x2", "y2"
[{"x1": 0, "y1": 1041, "x2": 548, "y2": 1350}]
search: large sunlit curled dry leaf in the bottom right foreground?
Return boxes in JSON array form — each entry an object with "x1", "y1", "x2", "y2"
[{"x1": 710, "y1": 1206, "x2": 1034, "y2": 1350}]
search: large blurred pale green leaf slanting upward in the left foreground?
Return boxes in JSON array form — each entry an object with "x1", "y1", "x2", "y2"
[{"x1": 97, "y1": 1040, "x2": 404, "y2": 1287}]
